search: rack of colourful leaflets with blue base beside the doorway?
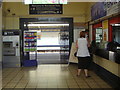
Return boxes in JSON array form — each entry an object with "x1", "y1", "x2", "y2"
[{"x1": 23, "y1": 31, "x2": 37, "y2": 67}]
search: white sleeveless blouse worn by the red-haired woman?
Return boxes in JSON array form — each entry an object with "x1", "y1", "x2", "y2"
[{"x1": 77, "y1": 38, "x2": 90, "y2": 57}]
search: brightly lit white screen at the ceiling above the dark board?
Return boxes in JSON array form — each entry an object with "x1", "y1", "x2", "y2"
[{"x1": 24, "y1": 0, "x2": 67, "y2": 4}]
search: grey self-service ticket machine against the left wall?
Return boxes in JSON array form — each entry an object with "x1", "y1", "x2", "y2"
[{"x1": 2, "y1": 30, "x2": 21, "y2": 68}]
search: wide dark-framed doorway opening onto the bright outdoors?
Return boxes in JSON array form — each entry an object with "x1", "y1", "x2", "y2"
[{"x1": 20, "y1": 18, "x2": 73, "y2": 64}]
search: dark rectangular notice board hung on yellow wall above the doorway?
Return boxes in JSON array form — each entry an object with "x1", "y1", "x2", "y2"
[{"x1": 29, "y1": 4, "x2": 63, "y2": 15}]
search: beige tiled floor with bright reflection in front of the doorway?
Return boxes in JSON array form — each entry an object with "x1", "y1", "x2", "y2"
[{"x1": 2, "y1": 64, "x2": 111, "y2": 90}]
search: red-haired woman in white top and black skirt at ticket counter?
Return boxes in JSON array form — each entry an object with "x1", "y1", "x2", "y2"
[{"x1": 76, "y1": 31, "x2": 90, "y2": 77}]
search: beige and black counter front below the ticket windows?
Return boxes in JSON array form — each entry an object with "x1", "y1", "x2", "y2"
[{"x1": 92, "y1": 54, "x2": 120, "y2": 88}]
